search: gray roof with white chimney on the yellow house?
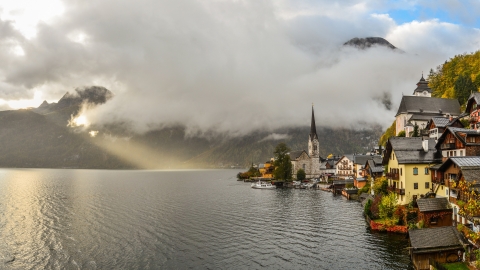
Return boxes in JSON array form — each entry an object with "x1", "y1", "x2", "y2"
[{"x1": 383, "y1": 137, "x2": 442, "y2": 165}]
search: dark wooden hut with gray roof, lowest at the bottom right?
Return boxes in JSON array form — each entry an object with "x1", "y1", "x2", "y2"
[{"x1": 408, "y1": 226, "x2": 470, "y2": 270}]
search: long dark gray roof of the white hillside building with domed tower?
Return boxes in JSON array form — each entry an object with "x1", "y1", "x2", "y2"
[{"x1": 395, "y1": 96, "x2": 460, "y2": 116}]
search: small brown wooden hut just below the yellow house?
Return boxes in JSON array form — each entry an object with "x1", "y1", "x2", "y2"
[{"x1": 417, "y1": 198, "x2": 452, "y2": 228}]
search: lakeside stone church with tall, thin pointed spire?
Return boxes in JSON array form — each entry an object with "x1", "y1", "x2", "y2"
[{"x1": 290, "y1": 106, "x2": 320, "y2": 179}]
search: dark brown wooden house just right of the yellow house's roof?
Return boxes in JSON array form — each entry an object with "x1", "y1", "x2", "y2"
[{"x1": 436, "y1": 127, "x2": 480, "y2": 161}]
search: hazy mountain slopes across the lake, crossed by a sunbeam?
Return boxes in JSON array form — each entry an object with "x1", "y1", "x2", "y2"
[{"x1": 0, "y1": 87, "x2": 381, "y2": 169}]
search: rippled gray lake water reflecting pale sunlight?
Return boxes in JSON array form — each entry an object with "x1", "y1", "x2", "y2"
[{"x1": 0, "y1": 169, "x2": 412, "y2": 269}]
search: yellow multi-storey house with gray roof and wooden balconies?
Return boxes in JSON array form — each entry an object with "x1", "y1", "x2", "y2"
[{"x1": 382, "y1": 137, "x2": 442, "y2": 205}]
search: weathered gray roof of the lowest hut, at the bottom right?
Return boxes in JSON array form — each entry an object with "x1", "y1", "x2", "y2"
[{"x1": 408, "y1": 226, "x2": 469, "y2": 253}]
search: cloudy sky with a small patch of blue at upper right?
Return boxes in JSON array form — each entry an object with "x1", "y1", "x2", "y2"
[{"x1": 0, "y1": 0, "x2": 480, "y2": 136}]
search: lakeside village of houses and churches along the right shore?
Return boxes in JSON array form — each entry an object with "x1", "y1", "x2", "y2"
[{"x1": 239, "y1": 75, "x2": 480, "y2": 269}]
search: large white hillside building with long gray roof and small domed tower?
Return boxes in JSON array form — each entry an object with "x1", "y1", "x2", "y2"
[{"x1": 395, "y1": 75, "x2": 460, "y2": 137}]
